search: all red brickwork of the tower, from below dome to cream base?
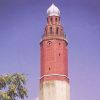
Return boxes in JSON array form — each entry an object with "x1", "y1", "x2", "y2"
[{"x1": 40, "y1": 16, "x2": 68, "y2": 80}]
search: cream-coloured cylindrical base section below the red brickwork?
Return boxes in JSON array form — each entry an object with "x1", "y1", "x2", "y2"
[{"x1": 39, "y1": 80, "x2": 70, "y2": 100}]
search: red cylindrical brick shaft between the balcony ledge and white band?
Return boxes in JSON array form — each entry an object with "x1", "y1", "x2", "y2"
[{"x1": 41, "y1": 39, "x2": 68, "y2": 76}]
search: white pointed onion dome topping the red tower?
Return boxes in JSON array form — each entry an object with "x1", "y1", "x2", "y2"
[{"x1": 47, "y1": 4, "x2": 60, "y2": 16}]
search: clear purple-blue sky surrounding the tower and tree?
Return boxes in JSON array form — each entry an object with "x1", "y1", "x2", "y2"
[{"x1": 0, "y1": 0, "x2": 100, "y2": 100}]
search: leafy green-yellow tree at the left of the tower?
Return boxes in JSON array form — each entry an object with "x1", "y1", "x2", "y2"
[{"x1": 0, "y1": 73, "x2": 27, "y2": 100}]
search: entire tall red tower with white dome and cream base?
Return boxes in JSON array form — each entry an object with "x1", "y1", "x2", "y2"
[{"x1": 40, "y1": 4, "x2": 70, "y2": 100}]
